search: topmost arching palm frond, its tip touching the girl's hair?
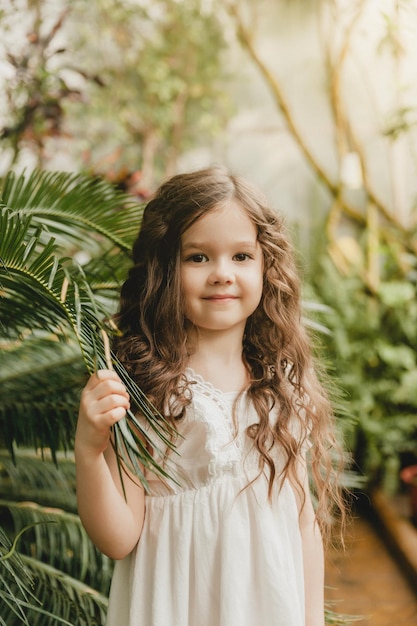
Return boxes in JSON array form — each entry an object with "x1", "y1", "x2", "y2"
[{"x1": 0, "y1": 170, "x2": 143, "y2": 252}]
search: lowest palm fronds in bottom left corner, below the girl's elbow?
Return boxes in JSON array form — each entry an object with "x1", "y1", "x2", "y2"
[{"x1": 0, "y1": 502, "x2": 112, "y2": 626}]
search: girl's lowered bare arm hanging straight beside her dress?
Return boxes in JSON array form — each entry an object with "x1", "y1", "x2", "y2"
[{"x1": 293, "y1": 454, "x2": 325, "y2": 626}]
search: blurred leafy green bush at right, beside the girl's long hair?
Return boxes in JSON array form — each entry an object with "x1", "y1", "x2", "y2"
[{"x1": 312, "y1": 248, "x2": 417, "y2": 491}]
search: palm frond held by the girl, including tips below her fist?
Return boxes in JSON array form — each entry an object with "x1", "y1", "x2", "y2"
[{"x1": 0, "y1": 201, "x2": 177, "y2": 489}]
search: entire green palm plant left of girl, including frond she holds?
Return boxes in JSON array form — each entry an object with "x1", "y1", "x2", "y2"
[{"x1": 0, "y1": 171, "x2": 177, "y2": 624}]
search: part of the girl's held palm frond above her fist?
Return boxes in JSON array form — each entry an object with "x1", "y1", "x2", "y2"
[{"x1": 0, "y1": 208, "x2": 106, "y2": 369}]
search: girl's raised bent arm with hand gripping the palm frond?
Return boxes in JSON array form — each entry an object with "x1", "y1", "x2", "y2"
[{"x1": 74, "y1": 370, "x2": 145, "y2": 559}]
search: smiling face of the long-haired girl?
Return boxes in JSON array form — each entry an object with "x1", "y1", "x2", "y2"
[{"x1": 181, "y1": 201, "x2": 263, "y2": 337}]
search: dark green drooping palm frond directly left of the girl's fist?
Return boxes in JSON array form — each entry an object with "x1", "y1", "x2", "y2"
[{"x1": 0, "y1": 334, "x2": 86, "y2": 458}]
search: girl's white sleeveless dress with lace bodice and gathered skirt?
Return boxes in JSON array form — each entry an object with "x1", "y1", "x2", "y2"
[{"x1": 106, "y1": 373, "x2": 305, "y2": 626}]
